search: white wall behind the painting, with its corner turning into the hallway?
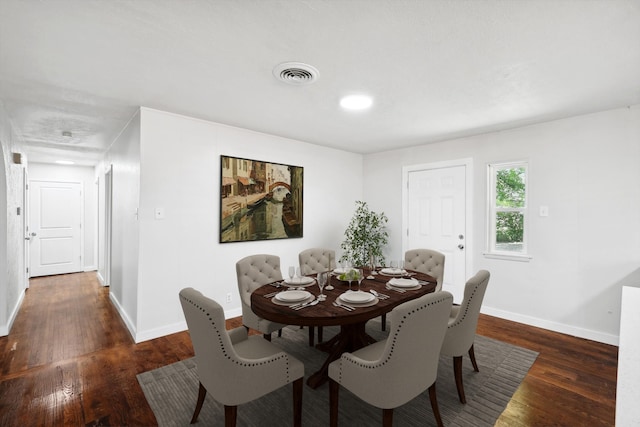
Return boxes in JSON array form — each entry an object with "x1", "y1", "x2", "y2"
[{"x1": 105, "y1": 108, "x2": 362, "y2": 342}]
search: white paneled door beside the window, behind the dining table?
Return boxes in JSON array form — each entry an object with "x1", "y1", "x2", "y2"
[{"x1": 404, "y1": 165, "x2": 467, "y2": 302}]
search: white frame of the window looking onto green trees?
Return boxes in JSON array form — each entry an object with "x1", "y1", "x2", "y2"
[{"x1": 484, "y1": 160, "x2": 532, "y2": 262}]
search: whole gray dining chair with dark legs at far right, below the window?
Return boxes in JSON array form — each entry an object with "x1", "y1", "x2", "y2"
[{"x1": 442, "y1": 270, "x2": 490, "y2": 403}]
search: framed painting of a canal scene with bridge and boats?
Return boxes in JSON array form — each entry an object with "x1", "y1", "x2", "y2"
[{"x1": 220, "y1": 156, "x2": 304, "y2": 243}]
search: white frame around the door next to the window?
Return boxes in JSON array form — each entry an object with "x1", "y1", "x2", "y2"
[{"x1": 401, "y1": 157, "x2": 474, "y2": 289}]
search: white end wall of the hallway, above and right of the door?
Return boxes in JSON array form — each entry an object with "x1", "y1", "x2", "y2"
[{"x1": 28, "y1": 162, "x2": 98, "y2": 271}]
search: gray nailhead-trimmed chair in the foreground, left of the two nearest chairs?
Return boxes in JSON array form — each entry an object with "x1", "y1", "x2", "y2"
[{"x1": 180, "y1": 288, "x2": 304, "y2": 427}]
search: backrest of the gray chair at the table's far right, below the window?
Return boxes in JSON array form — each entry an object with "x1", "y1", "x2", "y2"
[{"x1": 442, "y1": 270, "x2": 491, "y2": 357}]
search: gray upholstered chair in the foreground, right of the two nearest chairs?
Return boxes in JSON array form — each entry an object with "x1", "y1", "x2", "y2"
[{"x1": 329, "y1": 292, "x2": 453, "y2": 427}]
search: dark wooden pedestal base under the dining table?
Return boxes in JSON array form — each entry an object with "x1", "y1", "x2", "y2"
[{"x1": 307, "y1": 322, "x2": 376, "y2": 389}]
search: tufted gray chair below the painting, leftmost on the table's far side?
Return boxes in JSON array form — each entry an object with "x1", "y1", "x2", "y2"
[{"x1": 236, "y1": 254, "x2": 286, "y2": 341}]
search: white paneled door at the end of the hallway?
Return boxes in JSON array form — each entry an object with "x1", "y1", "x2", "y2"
[{"x1": 28, "y1": 181, "x2": 82, "y2": 277}]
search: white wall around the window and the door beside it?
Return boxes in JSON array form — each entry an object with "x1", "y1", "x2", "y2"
[{"x1": 363, "y1": 106, "x2": 640, "y2": 344}]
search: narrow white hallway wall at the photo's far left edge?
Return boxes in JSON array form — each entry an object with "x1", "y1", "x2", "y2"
[{"x1": 0, "y1": 102, "x2": 27, "y2": 336}]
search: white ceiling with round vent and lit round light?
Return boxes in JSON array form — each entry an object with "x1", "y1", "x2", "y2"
[{"x1": 0, "y1": 0, "x2": 640, "y2": 166}]
